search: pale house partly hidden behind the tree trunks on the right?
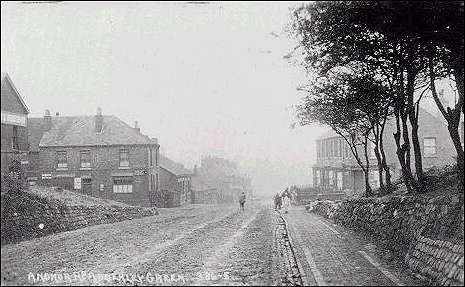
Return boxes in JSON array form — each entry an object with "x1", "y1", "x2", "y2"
[{"x1": 313, "y1": 108, "x2": 456, "y2": 195}]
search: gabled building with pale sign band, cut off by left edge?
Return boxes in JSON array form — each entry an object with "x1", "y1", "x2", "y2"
[{"x1": 1, "y1": 73, "x2": 29, "y2": 177}]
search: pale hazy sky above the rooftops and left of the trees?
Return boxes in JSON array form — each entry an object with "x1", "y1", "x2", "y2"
[{"x1": 1, "y1": 2, "x2": 330, "y2": 196}]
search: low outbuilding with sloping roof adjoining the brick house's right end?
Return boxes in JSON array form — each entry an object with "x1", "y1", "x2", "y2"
[{"x1": 157, "y1": 154, "x2": 192, "y2": 207}]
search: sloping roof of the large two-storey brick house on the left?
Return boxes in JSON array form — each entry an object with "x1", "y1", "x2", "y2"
[{"x1": 28, "y1": 115, "x2": 155, "y2": 150}]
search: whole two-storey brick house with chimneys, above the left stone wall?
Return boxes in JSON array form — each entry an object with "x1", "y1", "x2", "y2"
[{"x1": 29, "y1": 109, "x2": 159, "y2": 206}]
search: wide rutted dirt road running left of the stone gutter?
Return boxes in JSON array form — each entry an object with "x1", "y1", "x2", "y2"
[{"x1": 2, "y1": 205, "x2": 275, "y2": 285}]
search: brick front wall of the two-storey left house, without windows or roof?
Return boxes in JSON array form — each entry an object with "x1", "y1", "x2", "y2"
[{"x1": 39, "y1": 146, "x2": 157, "y2": 206}]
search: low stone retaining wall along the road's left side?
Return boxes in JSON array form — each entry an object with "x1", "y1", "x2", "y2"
[{"x1": 1, "y1": 193, "x2": 158, "y2": 245}]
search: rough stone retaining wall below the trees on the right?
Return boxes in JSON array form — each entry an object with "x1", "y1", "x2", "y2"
[{"x1": 307, "y1": 194, "x2": 464, "y2": 285}]
